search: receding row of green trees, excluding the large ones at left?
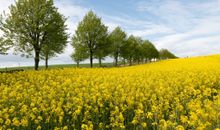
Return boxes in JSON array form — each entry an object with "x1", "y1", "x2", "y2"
[{"x1": 72, "y1": 11, "x2": 176, "y2": 67}]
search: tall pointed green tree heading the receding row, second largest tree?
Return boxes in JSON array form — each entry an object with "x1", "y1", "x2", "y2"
[{"x1": 73, "y1": 11, "x2": 108, "y2": 67}]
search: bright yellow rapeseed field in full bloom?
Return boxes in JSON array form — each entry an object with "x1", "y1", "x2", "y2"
[{"x1": 0, "y1": 55, "x2": 220, "y2": 130}]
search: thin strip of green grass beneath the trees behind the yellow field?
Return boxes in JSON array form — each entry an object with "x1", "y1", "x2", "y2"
[{"x1": 0, "y1": 63, "x2": 113, "y2": 71}]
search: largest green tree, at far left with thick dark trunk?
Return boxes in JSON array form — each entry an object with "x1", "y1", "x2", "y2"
[{"x1": 0, "y1": 0, "x2": 66, "y2": 70}]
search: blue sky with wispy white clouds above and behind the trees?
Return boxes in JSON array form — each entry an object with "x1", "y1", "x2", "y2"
[{"x1": 0, "y1": 0, "x2": 220, "y2": 67}]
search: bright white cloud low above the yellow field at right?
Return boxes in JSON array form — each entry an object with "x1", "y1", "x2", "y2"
[{"x1": 155, "y1": 12, "x2": 220, "y2": 56}]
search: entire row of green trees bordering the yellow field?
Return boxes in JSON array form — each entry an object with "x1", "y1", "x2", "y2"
[{"x1": 0, "y1": 0, "x2": 176, "y2": 70}]
